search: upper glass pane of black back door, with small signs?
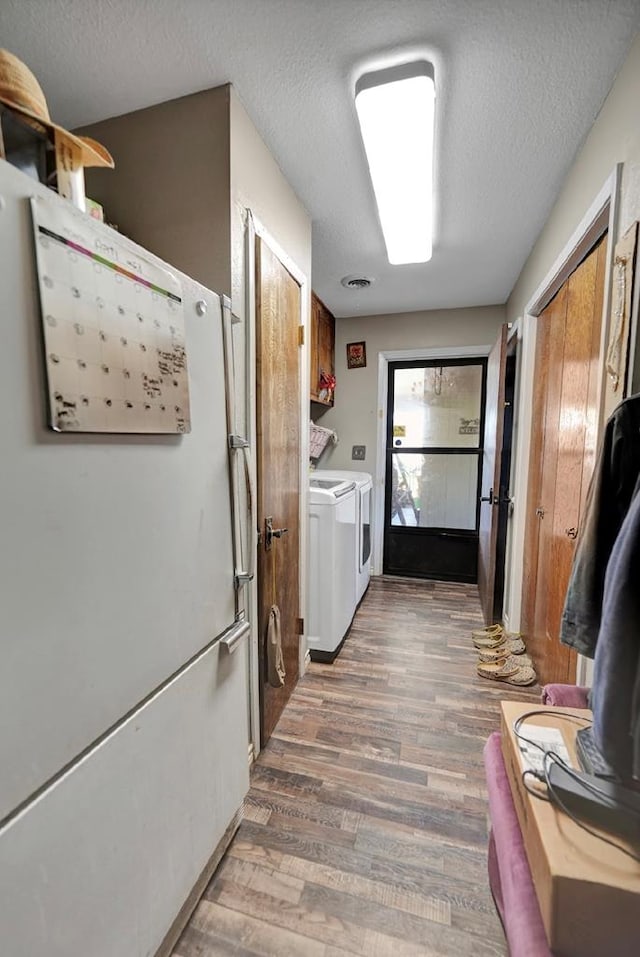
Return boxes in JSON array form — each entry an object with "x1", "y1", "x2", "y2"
[{"x1": 392, "y1": 365, "x2": 482, "y2": 449}]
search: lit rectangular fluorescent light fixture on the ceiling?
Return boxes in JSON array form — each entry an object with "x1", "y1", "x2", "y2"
[{"x1": 356, "y1": 61, "x2": 435, "y2": 265}]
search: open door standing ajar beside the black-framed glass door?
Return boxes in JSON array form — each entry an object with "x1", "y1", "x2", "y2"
[{"x1": 478, "y1": 323, "x2": 509, "y2": 625}]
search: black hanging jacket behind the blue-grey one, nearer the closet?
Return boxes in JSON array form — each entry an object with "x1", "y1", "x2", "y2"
[{"x1": 560, "y1": 395, "x2": 640, "y2": 658}]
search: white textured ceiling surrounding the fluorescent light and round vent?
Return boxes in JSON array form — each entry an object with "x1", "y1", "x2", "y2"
[{"x1": 0, "y1": 0, "x2": 640, "y2": 316}]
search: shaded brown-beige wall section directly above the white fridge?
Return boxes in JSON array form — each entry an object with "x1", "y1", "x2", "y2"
[{"x1": 80, "y1": 86, "x2": 231, "y2": 295}]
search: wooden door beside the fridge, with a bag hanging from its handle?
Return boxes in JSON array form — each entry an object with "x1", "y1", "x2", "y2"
[{"x1": 256, "y1": 239, "x2": 301, "y2": 745}]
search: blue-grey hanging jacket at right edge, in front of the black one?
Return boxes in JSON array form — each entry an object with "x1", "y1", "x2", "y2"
[{"x1": 591, "y1": 486, "x2": 640, "y2": 778}]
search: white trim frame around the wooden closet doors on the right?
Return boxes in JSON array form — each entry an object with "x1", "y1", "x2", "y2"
[{"x1": 504, "y1": 163, "x2": 622, "y2": 683}]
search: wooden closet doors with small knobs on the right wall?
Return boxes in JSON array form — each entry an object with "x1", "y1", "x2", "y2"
[{"x1": 522, "y1": 232, "x2": 607, "y2": 683}]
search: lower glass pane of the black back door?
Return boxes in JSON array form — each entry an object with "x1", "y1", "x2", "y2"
[{"x1": 390, "y1": 452, "x2": 479, "y2": 530}]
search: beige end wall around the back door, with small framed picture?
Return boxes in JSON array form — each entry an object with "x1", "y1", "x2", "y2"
[{"x1": 318, "y1": 306, "x2": 505, "y2": 475}]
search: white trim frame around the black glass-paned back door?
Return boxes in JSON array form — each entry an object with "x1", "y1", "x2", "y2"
[{"x1": 371, "y1": 343, "x2": 493, "y2": 575}]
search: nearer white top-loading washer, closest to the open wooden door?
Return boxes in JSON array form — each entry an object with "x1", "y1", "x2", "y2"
[{"x1": 307, "y1": 472, "x2": 358, "y2": 661}]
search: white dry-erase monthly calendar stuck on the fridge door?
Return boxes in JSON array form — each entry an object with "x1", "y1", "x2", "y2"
[{"x1": 31, "y1": 197, "x2": 191, "y2": 433}]
